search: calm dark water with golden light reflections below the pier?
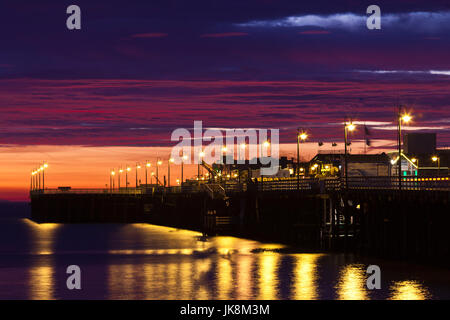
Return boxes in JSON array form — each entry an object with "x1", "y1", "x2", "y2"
[{"x1": 0, "y1": 218, "x2": 450, "y2": 299}]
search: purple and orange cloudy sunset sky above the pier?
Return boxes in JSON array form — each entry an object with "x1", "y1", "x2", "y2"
[{"x1": 0, "y1": 0, "x2": 450, "y2": 200}]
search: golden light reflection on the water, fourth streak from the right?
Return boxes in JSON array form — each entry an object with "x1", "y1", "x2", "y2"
[{"x1": 259, "y1": 252, "x2": 280, "y2": 300}]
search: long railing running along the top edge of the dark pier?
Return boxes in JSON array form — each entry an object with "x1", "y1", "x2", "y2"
[{"x1": 30, "y1": 176, "x2": 450, "y2": 197}]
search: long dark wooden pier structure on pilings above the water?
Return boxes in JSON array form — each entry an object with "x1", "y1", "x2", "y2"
[{"x1": 30, "y1": 177, "x2": 450, "y2": 263}]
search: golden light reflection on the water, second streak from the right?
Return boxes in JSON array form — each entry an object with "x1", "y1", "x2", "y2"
[{"x1": 336, "y1": 264, "x2": 368, "y2": 300}]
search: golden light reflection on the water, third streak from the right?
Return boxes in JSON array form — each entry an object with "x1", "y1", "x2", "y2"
[{"x1": 294, "y1": 254, "x2": 322, "y2": 300}]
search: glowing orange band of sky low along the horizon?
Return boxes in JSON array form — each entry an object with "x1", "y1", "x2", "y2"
[{"x1": 0, "y1": 140, "x2": 395, "y2": 201}]
